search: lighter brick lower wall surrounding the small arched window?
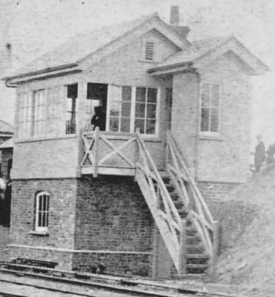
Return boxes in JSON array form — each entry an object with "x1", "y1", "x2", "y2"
[{"x1": 10, "y1": 179, "x2": 76, "y2": 249}]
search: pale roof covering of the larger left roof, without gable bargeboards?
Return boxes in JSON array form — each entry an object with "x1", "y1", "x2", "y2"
[{"x1": 7, "y1": 13, "x2": 187, "y2": 78}]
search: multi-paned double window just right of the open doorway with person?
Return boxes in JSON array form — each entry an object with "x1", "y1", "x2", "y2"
[{"x1": 109, "y1": 86, "x2": 158, "y2": 135}]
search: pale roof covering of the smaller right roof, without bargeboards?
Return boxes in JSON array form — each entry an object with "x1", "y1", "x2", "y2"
[{"x1": 149, "y1": 36, "x2": 268, "y2": 72}]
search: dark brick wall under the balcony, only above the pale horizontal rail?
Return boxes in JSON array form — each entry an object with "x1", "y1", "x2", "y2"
[{"x1": 75, "y1": 176, "x2": 153, "y2": 252}]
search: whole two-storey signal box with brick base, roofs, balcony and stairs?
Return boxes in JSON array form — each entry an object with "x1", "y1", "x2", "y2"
[{"x1": 3, "y1": 8, "x2": 267, "y2": 277}]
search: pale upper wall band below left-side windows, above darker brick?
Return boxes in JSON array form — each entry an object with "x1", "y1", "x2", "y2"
[{"x1": 12, "y1": 136, "x2": 78, "y2": 179}]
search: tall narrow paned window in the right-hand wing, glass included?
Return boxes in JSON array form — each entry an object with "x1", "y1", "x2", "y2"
[{"x1": 201, "y1": 83, "x2": 221, "y2": 133}]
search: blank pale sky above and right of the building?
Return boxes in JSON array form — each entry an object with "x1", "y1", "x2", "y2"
[{"x1": 0, "y1": 0, "x2": 275, "y2": 146}]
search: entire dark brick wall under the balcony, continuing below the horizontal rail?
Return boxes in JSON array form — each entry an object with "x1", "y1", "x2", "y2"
[{"x1": 74, "y1": 176, "x2": 153, "y2": 276}]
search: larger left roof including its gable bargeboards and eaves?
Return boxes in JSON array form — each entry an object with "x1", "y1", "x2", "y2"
[{"x1": 6, "y1": 14, "x2": 189, "y2": 80}]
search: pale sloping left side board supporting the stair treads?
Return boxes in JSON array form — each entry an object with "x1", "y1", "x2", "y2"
[{"x1": 136, "y1": 169, "x2": 180, "y2": 271}]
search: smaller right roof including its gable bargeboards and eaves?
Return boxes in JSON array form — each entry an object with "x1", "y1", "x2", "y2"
[{"x1": 149, "y1": 36, "x2": 268, "y2": 75}]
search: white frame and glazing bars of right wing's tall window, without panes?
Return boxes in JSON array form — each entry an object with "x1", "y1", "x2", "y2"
[{"x1": 199, "y1": 81, "x2": 223, "y2": 137}]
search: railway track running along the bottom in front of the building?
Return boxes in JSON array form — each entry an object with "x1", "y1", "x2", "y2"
[{"x1": 0, "y1": 263, "x2": 242, "y2": 297}]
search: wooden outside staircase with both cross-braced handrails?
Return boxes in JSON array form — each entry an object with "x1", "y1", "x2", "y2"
[{"x1": 136, "y1": 132, "x2": 218, "y2": 275}]
